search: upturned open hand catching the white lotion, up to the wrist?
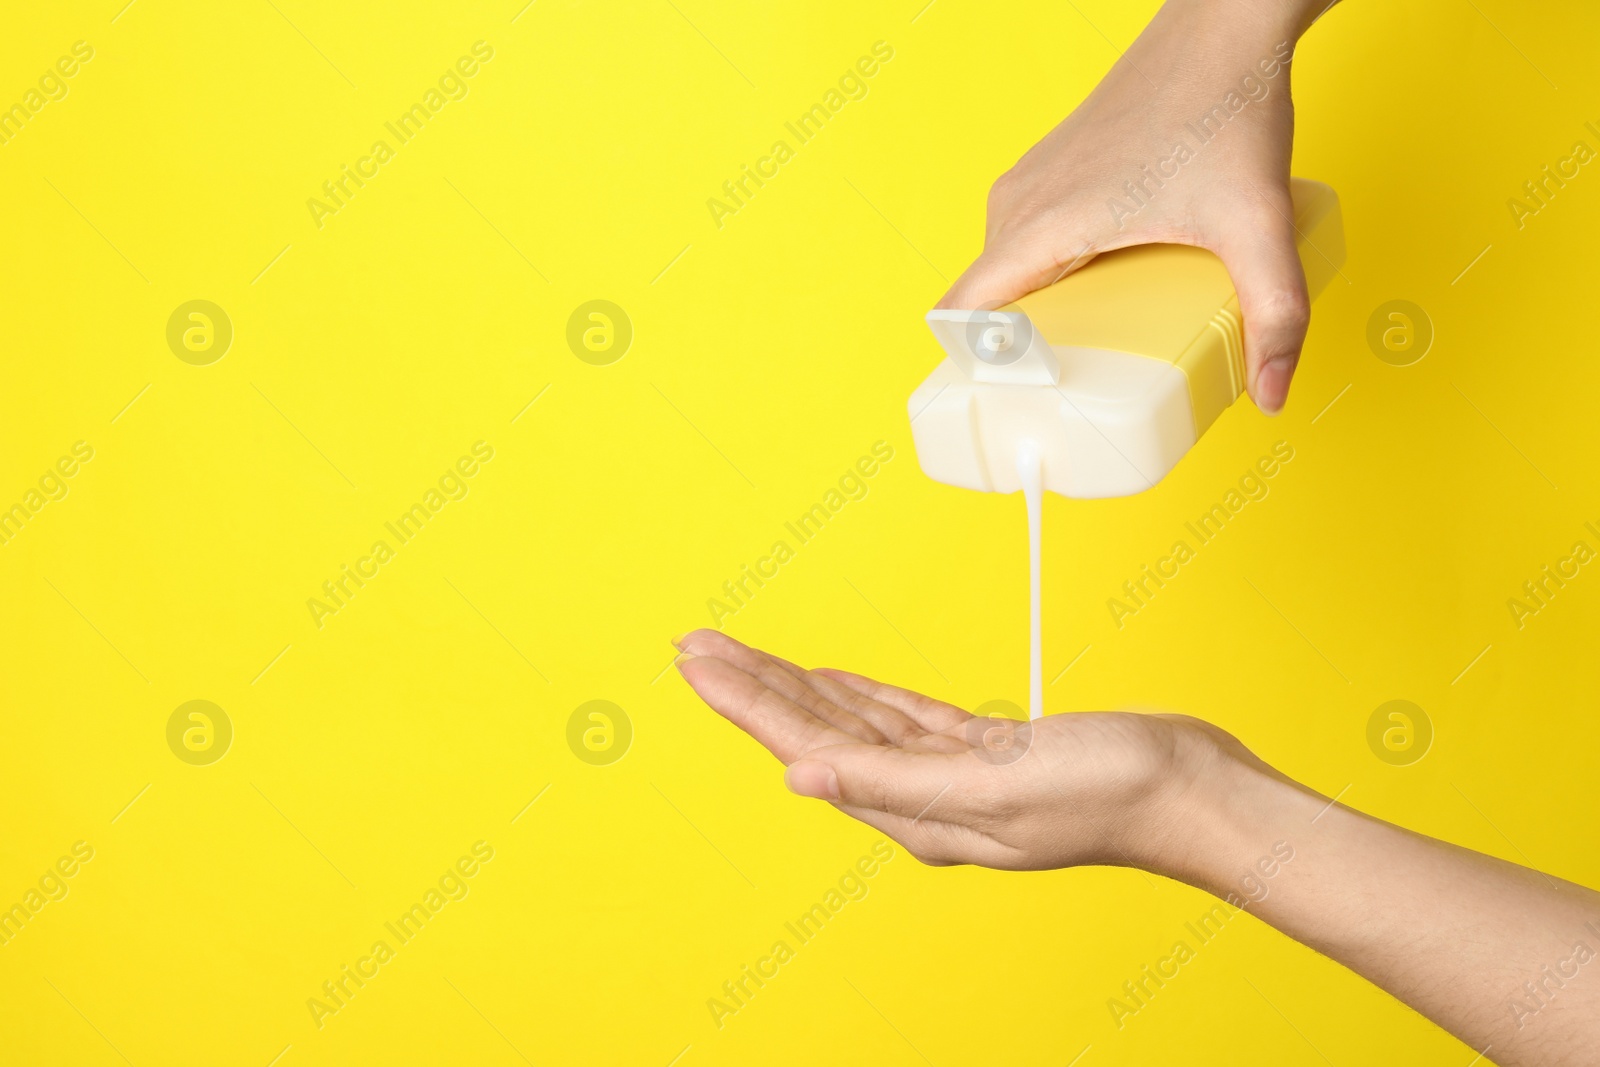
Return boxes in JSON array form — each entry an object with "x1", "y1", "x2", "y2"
[{"x1": 677, "y1": 630, "x2": 1253, "y2": 873}]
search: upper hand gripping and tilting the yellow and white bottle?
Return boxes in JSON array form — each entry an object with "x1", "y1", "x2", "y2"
[{"x1": 939, "y1": 0, "x2": 1330, "y2": 414}]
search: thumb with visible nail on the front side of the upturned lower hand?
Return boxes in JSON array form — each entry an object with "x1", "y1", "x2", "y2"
[{"x1": 784, "y1": 744, "x2": 978, "y2": 822}]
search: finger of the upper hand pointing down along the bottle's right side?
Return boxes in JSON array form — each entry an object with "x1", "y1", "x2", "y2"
[{"x1": 1218, "y1": 189, "x2": 1310, "y2": 414}]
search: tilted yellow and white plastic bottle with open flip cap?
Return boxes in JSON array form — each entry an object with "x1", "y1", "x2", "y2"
[{"x1": 909, "y1": 178, "x2": 1344, "y2": 498}]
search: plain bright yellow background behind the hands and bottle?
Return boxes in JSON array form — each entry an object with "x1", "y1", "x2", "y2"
[{"x1": 0, "y1": 0, "x2": 1600, "y2": 1067}]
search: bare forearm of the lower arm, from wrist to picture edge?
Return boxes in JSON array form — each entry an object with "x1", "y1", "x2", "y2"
[{"x1": 1173, "y1": 765, "x2": 1600, "y2": 1067}]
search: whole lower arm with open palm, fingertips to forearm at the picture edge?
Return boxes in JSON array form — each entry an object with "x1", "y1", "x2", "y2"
[{"x1": 678, "y1": 630, "x2": 1600, "y2": 1067}]
